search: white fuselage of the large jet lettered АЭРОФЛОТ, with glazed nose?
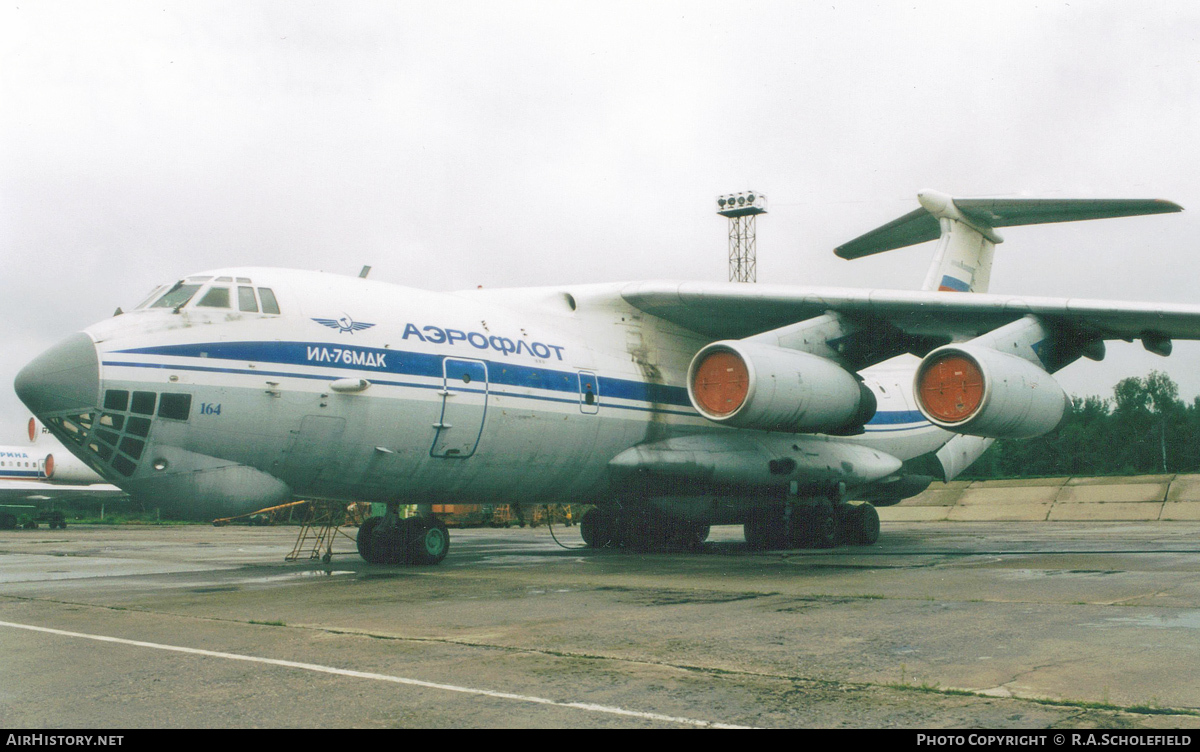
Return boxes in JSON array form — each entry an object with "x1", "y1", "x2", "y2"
[{"x1": 17, "y1": 269, "x2": 953, "y2": 516}]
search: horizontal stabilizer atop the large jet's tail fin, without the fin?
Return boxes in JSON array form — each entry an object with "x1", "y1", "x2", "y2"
[{"x1": 834, "y1": 191, "x2": 1183, "y2": 259}]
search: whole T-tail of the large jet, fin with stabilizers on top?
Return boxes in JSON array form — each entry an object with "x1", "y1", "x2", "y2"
[{"x1": 834, "y1": 191, "x2": 1183, "y2": 293}]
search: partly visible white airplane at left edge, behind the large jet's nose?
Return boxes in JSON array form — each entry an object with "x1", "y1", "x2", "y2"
[{"x1": 0, "y1": 419, "x2": 126, "y2": 530}]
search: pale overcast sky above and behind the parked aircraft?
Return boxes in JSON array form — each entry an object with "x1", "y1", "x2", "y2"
[{"x1": 0, "y1": 0, "x2": 1200, "y2": 436}]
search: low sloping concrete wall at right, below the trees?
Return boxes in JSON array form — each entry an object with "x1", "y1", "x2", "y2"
[{"x1": 880, "y1": 475, "x2": 1200, "y2": 522}]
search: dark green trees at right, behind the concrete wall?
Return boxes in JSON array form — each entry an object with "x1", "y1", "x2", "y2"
[{"x1": 961, "y1": 371, "x2": 1200, "y2": 480}]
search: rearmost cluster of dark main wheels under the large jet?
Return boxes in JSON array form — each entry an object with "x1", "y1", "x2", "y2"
[{"x1": 743, "y1": 499, "x2": 880, "y2": 551}]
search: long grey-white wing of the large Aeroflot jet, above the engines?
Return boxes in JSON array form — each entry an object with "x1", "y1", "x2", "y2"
[{"x1": 620, "y1": 282, "x2": 1200, "y2": 355}]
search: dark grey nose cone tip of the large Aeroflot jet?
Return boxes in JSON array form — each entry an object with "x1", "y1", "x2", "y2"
[{"x1": 13, "y1": 332, "x2": 100, "y2": 416}]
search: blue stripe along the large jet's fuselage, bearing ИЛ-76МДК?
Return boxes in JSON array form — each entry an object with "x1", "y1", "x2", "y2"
[{"x1": 104, "y1": 342, "x2": 925, "y2": 431}]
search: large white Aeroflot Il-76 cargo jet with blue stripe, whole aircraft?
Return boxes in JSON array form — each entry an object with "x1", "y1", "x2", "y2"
[{"x1": 16, "y1": 192, "x2": 1200, "y2": 563}]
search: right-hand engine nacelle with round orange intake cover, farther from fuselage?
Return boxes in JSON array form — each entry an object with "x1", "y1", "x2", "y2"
[{"x1": 913, "y1": 343, "x2": 1070, "y2": 439}]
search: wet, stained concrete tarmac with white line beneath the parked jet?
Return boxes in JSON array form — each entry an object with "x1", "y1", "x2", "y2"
[{"x1": 0, "y1": 522, "x2": 1200, "y2": 729}]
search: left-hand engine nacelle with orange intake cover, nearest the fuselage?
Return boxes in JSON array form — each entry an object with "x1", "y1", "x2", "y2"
[{"x1": 688, "y1": 341, "x2": 877, "y2": 433}]
